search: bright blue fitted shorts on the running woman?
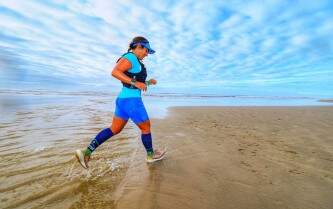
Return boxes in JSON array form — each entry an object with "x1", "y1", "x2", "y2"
[{"x1": 115, "y1": 97, "x2": 149, "y2": 124}]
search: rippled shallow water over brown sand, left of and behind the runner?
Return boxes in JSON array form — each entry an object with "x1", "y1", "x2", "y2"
[{"x1": 0, "y1": 94, "x2": 140, "y2": 208}]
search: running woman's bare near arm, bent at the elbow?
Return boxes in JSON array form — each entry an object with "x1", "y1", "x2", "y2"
[{"x1": 111, "y1": 58, "x2": 147, "y2": 91}]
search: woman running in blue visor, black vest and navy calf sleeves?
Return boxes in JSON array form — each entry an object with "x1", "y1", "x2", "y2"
[{"x1": 75, "y1": 36, "x2": 165, "y2": 168}]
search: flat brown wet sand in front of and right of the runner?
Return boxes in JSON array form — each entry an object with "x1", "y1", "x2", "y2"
[{"x1": 113, "y1": 107, "x2": 333, "y2": 209}]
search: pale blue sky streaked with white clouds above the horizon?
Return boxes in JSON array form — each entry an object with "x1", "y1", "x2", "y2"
[{"x1": 0, "y1": 0, "x2": 333, "y2": 97}]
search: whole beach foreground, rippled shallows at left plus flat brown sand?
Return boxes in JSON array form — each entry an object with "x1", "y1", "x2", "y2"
[{"x1": 0, "y1": 105, "x2": 333, "y2": 209}]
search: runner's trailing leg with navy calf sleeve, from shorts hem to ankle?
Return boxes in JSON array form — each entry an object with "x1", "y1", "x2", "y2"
[{"x1": 86, "y1": 116, "x2": 127, "y2": 155}]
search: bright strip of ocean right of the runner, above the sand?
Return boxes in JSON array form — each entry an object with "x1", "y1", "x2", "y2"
[{"x1": 143, "y1": 94, "x2": 332, "y2": 118}]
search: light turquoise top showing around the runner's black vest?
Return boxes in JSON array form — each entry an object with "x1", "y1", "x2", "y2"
[{"x1": 118, "y1": 53, "x2": 141, "y2": 98}]
